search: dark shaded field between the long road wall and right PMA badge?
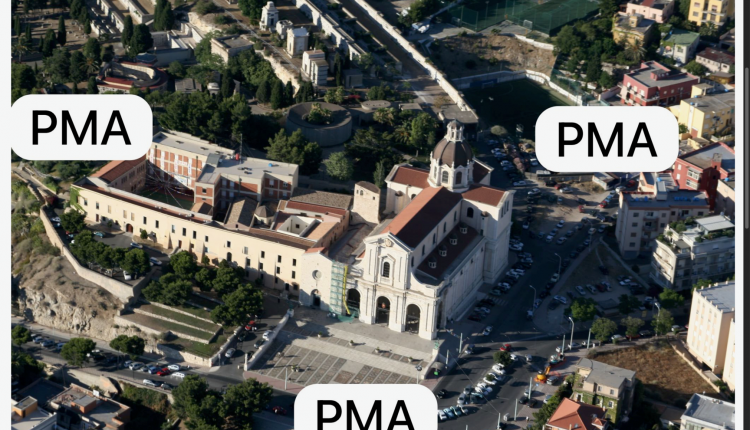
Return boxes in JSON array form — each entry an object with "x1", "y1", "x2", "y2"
[{"x1": 464, "y1": 79, "x2": 573, "y2": 140}]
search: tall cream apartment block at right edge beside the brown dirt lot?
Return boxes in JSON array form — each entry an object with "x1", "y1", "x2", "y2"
[{"x1": 686, "y1": 281, "x2": 735, "y2": 374}]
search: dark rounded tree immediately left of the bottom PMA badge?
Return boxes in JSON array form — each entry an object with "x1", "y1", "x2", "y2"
[{"x1": 221, "y1": 378, "x2": 273, "y2": 424}]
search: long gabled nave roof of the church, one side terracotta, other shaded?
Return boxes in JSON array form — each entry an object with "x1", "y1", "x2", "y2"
[{"x1": 383, "y1": 187, "x2": 461, "y2": 248}]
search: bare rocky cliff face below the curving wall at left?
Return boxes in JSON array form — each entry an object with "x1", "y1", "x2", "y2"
[{"x1": 13, "y1": 249, "x2": 145, "y2": 341}]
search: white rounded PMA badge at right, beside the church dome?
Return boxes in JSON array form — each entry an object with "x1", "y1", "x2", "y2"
[{"x1": 535, "y1": 106, "x2": 680, "y2": 173}]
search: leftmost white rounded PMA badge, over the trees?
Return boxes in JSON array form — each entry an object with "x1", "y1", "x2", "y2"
[{"x1": 8, "y1": 94, "x2": 153, "y2": 161}]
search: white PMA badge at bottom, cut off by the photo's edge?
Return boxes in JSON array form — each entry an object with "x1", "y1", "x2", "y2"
[{"x1": 294, "y1": 384, "x2": 438, "y2": 430}]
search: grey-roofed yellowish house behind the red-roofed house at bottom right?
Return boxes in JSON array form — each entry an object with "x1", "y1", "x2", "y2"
[{"x1": 570, "y1": 358, "x2": 636, "y2": 425}]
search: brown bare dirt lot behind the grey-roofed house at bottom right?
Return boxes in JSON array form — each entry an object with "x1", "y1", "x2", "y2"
[{"x1": 594, "y1": 341, "x2": 715, "y2": 404}]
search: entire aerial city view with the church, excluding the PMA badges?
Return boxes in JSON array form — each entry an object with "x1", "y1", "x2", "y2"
[{"x1": 10, "y1": 0, "x2": 741, "y2": 430}]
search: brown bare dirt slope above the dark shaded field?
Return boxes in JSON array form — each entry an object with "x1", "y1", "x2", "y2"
[{"x1": 430, "y1": 33, "x2": 557, "y2": 78}]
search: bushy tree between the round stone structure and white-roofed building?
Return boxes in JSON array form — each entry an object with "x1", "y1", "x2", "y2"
[{"x1": 266, "y1": 130, "x2": 323, "y2": 175}]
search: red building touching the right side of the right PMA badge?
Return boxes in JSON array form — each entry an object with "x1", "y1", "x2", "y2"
[{"x1": 672, "y1": 142, "x2": 735, "y2": 209}]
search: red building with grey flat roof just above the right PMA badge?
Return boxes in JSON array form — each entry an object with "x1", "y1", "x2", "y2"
[{"x1": 620, "y1": 61, "x2": 700, "y2": 106}]
